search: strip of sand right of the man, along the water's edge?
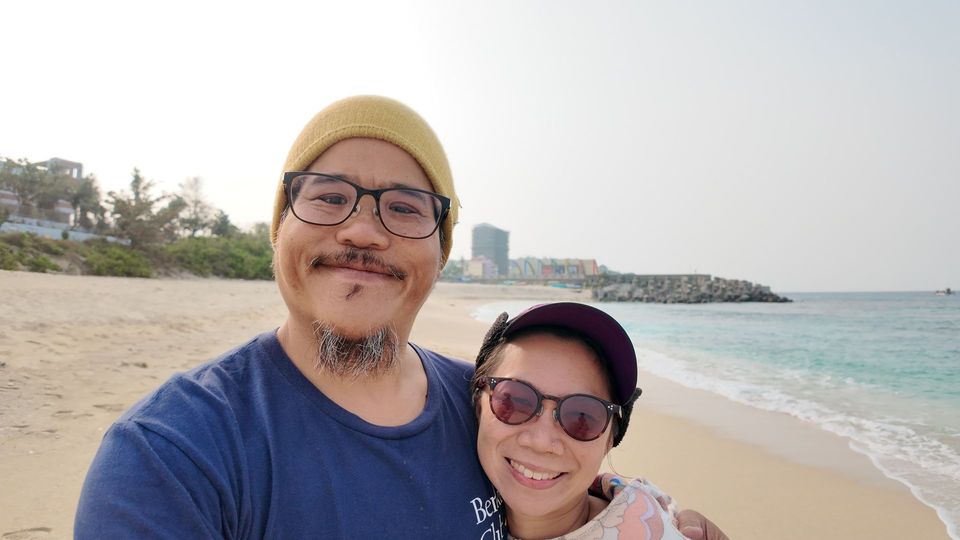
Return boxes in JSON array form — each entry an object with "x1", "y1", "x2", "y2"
[{"x1": 413, "y1": 284, "x2": 949, "y2": 540}]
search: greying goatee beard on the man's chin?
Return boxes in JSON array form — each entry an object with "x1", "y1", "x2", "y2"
[{"x1": 313, "y1": 321, "x2": 400, "y2": 380}]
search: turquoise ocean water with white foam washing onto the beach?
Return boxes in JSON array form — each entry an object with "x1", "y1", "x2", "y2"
[{"x1": 474, "y1": 292, "x2": 960, "y2": 540}]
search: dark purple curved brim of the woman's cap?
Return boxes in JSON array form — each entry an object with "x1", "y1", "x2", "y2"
[{"x1": 503, "y1": 302, "x2": 637, "y2": 405}]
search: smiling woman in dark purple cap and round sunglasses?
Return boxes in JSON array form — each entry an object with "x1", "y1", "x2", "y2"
[{"x1": 472, "y1": 302, "x2": 683, "y2": 539}]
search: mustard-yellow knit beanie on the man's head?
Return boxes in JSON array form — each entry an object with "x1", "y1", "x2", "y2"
[{"x1": 270, "y1": 96, "x2": 460, "y2": 262}]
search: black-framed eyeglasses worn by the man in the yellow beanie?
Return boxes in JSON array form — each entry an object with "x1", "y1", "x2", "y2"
[{"x1": 283, "y1": 171, "x2": 450, "y2": 239}]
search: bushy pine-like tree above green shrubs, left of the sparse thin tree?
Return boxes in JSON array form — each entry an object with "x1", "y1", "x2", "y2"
[{"x1": 107, "y1": 169, "x2": 186, "y2": 249}]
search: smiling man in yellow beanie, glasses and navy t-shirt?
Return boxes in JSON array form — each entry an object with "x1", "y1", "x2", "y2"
[{"x1": 75, "y1": 96, "x2": 724, "y2": 540}]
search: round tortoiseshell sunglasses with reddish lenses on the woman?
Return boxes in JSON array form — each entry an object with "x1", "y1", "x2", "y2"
[{"x1": 478, "y1": 377, "x2": 620, "y2": 442}]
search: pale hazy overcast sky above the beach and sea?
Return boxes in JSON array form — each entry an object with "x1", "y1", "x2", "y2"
[{"x1": 0, "y1": 0, "x2": 960, "y2": 292}]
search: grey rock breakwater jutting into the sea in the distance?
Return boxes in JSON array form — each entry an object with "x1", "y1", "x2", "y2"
[{"x1": 587, "y1": 274, "x2": 792, "y2": 304}]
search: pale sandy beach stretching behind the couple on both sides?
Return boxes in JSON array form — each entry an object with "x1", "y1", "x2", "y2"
[{"x1": 0, "y1": 271, "x2": 948, "y2": 540}]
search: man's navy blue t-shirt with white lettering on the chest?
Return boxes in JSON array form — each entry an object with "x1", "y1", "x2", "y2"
[{"x1": 75, "y1": 333, "x2": 505, "y2": 540}]
